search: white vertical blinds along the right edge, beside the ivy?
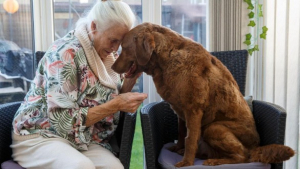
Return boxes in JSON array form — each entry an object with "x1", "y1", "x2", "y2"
[{"x1": 261, "y1": 0, "x2": 300, "y2": 169}]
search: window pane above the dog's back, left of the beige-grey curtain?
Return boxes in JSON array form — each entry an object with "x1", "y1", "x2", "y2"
[{"x1": 162, "y1": 0, "x2": 207, "y2": 47}]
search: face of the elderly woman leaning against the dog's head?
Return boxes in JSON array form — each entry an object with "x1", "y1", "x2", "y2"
[{"x1": 91, "y1": 22, "x2": 129, "y2": 59}]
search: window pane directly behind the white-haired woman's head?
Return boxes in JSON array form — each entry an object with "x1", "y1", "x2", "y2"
[{"x1": 54, "y1": 0, "x2": 143, "y2": 92}]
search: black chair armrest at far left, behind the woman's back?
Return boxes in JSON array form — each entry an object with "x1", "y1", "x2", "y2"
[{"x1": 0, "y1": 102, "x2": 21, "y2": 164}]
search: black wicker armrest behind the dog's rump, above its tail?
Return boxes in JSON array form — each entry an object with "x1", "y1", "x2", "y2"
[{"x1": 252, "y1": 100, "x2": 286, "y2": 169}]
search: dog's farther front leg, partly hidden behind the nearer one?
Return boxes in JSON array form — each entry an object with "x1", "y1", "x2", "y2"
[{"x1": 169, "y1": 116, "x2": 186, "y2": 155}]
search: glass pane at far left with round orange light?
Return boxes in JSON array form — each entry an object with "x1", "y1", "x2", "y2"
[{"x1": 0, "y1": 0, "x2": 34, "y2": 104}]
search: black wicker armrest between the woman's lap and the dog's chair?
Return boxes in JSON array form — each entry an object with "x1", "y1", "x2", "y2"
[{"x1": 118, "y1": 112, "x2": 136, "y2": 169}]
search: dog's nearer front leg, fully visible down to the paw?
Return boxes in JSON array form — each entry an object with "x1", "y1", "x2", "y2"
[{"x1": 175, "y1": 110, "x2": 203, "y2": 167}]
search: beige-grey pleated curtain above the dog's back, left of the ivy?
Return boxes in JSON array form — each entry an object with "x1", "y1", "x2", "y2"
[{"x1": 208, "y1": 0, "x2": 249, "y2": 51}]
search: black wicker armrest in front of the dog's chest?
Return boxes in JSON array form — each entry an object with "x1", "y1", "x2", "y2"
[{"x1": 141, "y1": 101, "x2": 178, "y2": 169}]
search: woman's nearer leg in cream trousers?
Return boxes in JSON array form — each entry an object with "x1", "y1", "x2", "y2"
[{"x1": 11, "y1": 136, "x2": 95, "y2": 169}]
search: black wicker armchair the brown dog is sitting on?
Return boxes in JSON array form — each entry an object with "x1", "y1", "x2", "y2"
[{"x1": 140, "y1": 50, "x2": 286, "y2": 169}]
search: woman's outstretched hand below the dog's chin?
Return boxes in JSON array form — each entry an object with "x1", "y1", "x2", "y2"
[{"x1": 112, "y1": 92, "x2": 148, "y2": 113}]
